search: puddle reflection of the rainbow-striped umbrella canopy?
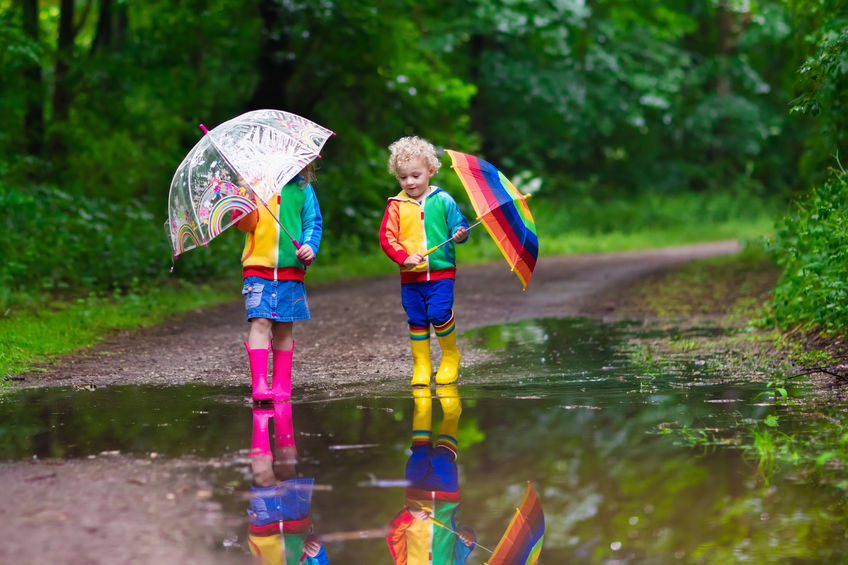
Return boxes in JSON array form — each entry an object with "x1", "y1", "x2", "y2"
[{"x1": 486, "y1": 482, "x2": 545, "y2": 565}]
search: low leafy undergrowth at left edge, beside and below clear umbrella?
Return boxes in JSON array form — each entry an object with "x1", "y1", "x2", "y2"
[{"x1": 0, "y1": 184, "x2": 242, "y2": 308}]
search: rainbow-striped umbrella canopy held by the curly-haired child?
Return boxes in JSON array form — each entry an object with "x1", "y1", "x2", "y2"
[{"x1": 445, "y1": 149, "x2": 539, "y2": 290}]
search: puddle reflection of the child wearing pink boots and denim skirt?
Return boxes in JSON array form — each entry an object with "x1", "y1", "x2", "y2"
[{"x1": 247, "y1": 402, "x2": 329, "y2": 565}]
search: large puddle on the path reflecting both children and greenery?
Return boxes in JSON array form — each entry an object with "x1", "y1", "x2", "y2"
[{"x1": 0, "y1": 319, "x2": 848, "y2": 565}]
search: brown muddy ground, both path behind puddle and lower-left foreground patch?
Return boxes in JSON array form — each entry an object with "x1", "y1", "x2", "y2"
[{"x1": 0, "y1": 242, "x2": 739, "y2": 564}]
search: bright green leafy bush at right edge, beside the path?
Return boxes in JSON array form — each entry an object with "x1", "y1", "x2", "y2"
[{"x1": 769, "y1": 167, "x2": 848, "y2": 331}]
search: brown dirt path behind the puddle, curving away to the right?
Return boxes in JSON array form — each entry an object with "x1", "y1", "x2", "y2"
[{"x1": 14, "y1": 241, "x2": 739, "y2": 390}]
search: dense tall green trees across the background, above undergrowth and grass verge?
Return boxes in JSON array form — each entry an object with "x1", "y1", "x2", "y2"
[{"x1": 0, "y1": 0, "x2": 846, "y2": 290}]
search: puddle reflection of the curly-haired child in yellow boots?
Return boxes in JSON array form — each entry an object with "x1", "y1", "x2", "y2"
[{"x1": 386, "y1": 385, "x2": 477, "y2": 565}]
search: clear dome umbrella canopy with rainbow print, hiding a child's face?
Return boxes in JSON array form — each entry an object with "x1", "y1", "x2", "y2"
[{"x1": 167, "y1": 110, "x2": 333, "y2": 256}]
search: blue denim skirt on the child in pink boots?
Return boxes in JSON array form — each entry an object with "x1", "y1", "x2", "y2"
[{"x1": 241, "y1": 277, "x2": 309, "y2": 322}]
